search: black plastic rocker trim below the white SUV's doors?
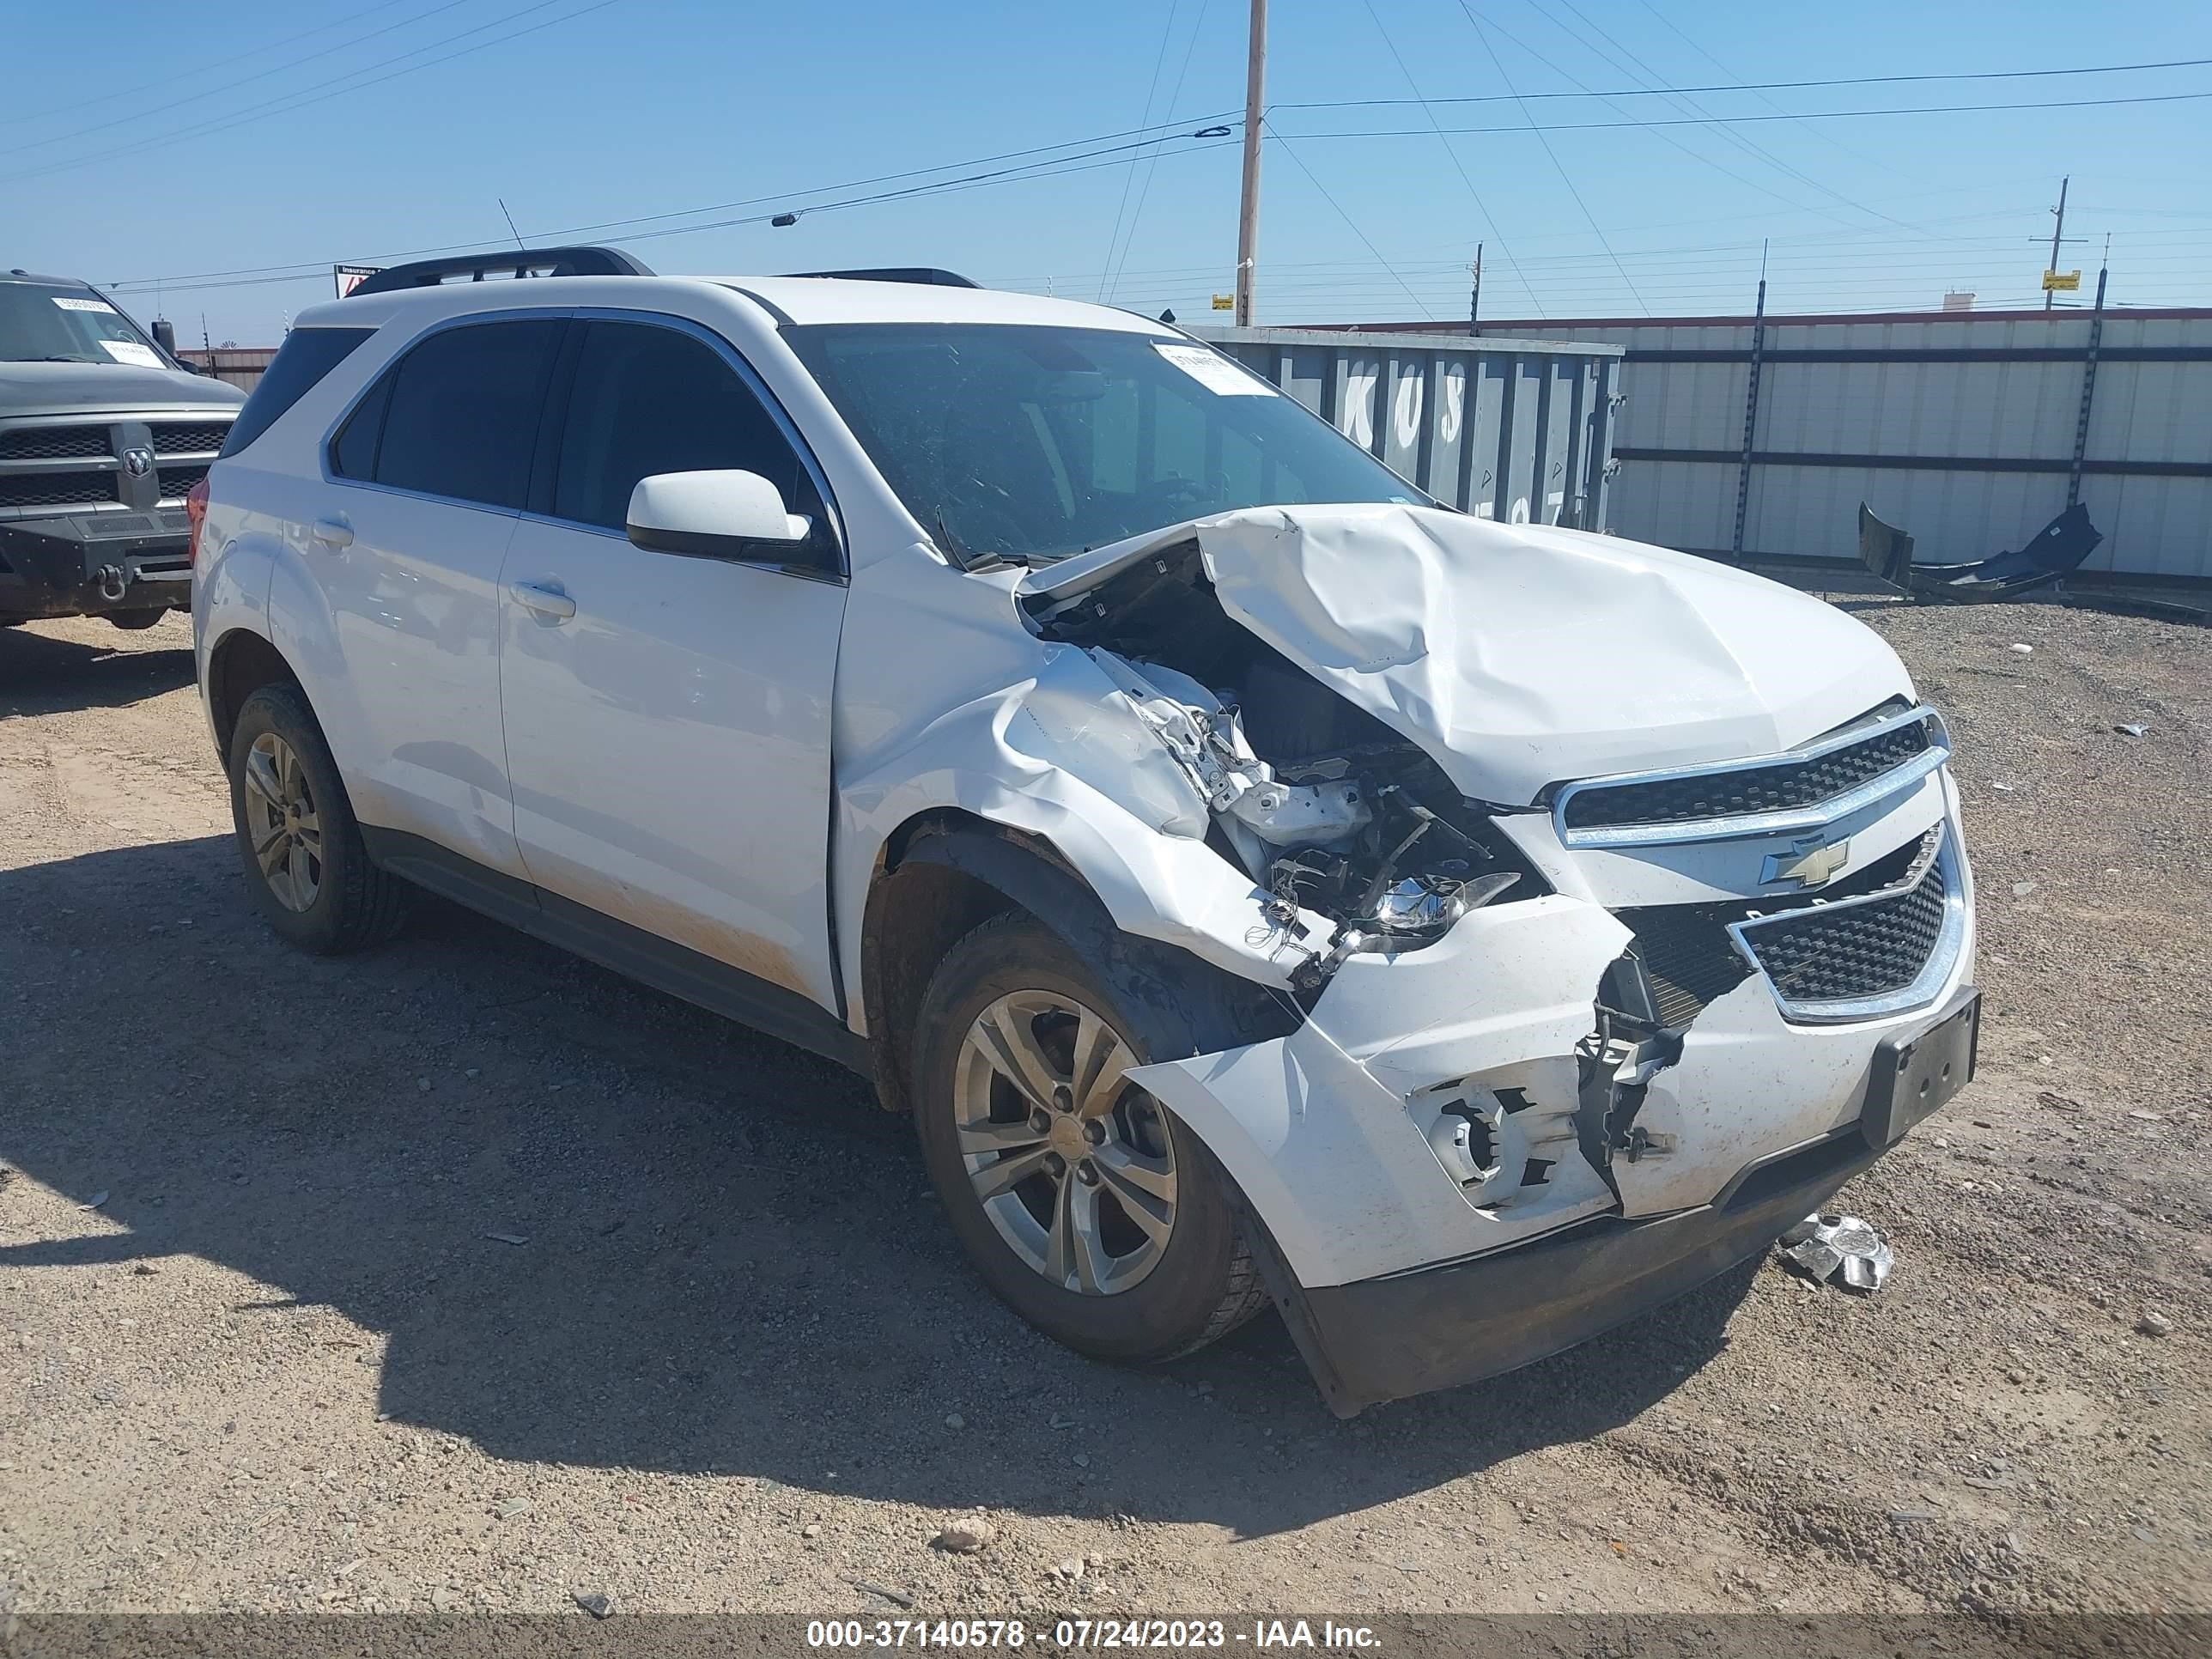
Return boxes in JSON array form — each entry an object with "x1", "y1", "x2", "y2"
[{"x1": 361, "y1": 825, "x2": 872, "y2": 1078}]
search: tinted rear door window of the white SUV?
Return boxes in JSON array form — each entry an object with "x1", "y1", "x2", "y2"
[{"x1": 354, "y1": 319, "x2": 566, "y2": 507}]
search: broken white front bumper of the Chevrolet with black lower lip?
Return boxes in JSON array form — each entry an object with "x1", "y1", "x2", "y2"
[{"x1": 1130, "y1": 799, "x2": 1973, "y2": 1411}]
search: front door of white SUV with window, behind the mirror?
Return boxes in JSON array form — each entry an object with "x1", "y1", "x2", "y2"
[{"x1": 500, "y1": 314, "x2": 845, "y2": 1011}]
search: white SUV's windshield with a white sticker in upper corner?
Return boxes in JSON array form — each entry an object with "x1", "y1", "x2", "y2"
[{"x1": 783, "y1": 323, "x2": 1425, "y2": 562}]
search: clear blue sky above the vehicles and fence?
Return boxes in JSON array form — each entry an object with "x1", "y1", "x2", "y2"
[{"x1": 0, "y1": 0, "x2": 2212, "y2": 343}]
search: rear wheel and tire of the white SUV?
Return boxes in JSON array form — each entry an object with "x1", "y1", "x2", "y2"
[{"x1": 230, "y1": 686, "x2": 404, "y2": 956}]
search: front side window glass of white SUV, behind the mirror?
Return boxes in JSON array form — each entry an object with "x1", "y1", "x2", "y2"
[{"x1": 553, "y1": 323, "x2": 827, "y2": 550}]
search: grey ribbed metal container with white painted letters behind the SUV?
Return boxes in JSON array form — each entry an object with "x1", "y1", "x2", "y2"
[{"x1": 1199, "y1": 327, "x2": 1621, "y2": 529}]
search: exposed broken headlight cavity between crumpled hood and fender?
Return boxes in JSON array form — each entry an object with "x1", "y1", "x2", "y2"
[{"x1": 1040, "y1": 542, "x2": 1551, "y2": 991}]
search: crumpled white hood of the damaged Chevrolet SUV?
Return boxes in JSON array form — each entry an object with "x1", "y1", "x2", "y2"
[{"x1": 1106, "y1": 507, "x2": 1913, "y2": 805}]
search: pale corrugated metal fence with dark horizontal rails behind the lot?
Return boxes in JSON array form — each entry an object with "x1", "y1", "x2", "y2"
[{"x1": 1450, "y1": 310, "x2": 2212, "y2": 580}]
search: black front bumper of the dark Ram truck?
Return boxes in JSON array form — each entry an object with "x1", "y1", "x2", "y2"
[{"x1": 0, "y1": 507, "x2": 192, "y2": 619}]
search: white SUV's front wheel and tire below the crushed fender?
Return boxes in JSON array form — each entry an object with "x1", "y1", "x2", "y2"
[{"x1": 914, "y1": 911, "x2": 1267, "y2": 1364}]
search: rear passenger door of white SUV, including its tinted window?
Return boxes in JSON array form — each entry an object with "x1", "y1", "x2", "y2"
[{"x1": 305, "y1": 314, "x2": 568, "y2": 876}]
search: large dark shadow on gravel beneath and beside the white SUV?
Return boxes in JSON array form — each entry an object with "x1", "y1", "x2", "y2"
[{"x1": 0, "y1": 836, "x2": 1756, "y2": 1535}]
